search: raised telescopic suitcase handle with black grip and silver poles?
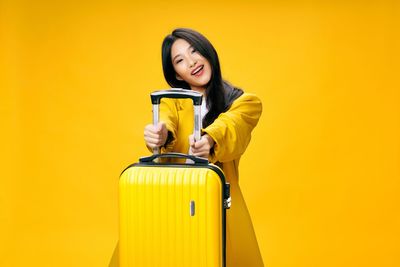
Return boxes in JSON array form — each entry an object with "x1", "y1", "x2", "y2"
[{"x1": 150, "y1": 88, "x2": 203, "y2": 154}]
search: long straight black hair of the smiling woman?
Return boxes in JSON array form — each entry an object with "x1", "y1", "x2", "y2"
[{"x1": 162, "y1": 28, "x2": 243, "y2": 128}]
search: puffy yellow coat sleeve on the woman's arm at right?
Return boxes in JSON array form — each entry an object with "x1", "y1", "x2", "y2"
[{"x1": 203, "y1": 94, "x2": 262, "y2": 162}]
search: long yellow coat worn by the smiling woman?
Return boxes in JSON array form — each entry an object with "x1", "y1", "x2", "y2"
[{"x1": 160, "y1": 93, "x2": 264, "y2": 267}]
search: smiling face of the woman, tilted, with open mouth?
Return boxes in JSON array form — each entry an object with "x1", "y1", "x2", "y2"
[{"x1": 171, "y1": 39, "x2": 212, "y2": 90}]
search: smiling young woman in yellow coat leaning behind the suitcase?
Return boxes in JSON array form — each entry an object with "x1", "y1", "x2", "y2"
[{"x1": 144, "y1": 28, "x2": 264, "y2": 267}]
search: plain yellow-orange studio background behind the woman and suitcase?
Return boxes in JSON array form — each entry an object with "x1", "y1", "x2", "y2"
[{"x1": 0, "y1": 0, "x2": 400, "y2": 267}]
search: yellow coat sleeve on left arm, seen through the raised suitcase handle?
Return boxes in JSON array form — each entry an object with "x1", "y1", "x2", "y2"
[{"x1": 147, "y1": 99, "x2": 178, "y2": 153}]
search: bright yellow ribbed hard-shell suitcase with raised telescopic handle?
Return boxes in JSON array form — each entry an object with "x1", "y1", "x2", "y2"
[{"x1": 119, "y1": 89, "x2": 230, "y2": 267}]
